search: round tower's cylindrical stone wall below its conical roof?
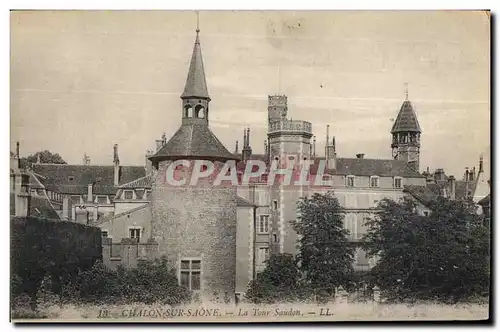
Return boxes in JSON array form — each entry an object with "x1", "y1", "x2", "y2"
[{"x1": 151, "y1": 161, "x2": 236, "y2": 301}]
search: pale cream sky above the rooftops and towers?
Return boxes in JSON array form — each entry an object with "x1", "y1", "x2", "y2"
[{"x1": 10, "y1": 11, "x2": 490, "y2": 177}]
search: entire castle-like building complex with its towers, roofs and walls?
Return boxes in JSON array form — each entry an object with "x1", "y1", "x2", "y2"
[{"x1": 21, "y1": 30, "x2": 482, "y2": 302}]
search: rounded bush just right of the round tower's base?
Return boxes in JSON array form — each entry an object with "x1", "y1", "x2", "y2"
[{"x1": 245, "y1": 254, "x2": 310, "y2": 303}]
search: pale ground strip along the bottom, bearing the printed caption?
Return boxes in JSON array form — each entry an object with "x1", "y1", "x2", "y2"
[{"x1": 14, "y1": 303, "x2": 488, "y2": 322}]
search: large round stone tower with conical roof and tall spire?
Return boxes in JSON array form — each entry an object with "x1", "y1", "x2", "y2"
[{"x1": 149, "y1": 22, "x2": 238, "y2": 301}]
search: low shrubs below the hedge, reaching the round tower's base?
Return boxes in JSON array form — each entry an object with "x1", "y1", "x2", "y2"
[{"x1": 11, "y1": 257, "x2": 191, "y2": 318}]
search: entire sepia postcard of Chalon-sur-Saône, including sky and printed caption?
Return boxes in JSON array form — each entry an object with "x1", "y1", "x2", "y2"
[{"x1": 10, "y1": 10, "x2": 491, "y2": 323}]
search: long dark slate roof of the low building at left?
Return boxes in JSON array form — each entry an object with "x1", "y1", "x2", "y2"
[{"x1": 33, "y1": 164, "x2": 146, "y2": 195}]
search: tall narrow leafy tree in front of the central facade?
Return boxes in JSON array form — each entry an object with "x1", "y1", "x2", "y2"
[{"x1": 292, "y1": 192, "x2": 355, "y2": 297}]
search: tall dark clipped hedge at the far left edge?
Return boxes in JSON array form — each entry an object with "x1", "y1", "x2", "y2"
[{"x1": 11, "y1": 217, "x2": 102, "y2": 297}]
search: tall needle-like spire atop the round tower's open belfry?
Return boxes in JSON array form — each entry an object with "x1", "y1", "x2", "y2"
[{"x1": 181, "y1": 30, "x2": 210, "y2": 99}]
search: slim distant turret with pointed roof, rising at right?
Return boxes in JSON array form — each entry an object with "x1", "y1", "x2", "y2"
[{"x1": 391, "y1": 86, "x2": 422, "y2": 171}]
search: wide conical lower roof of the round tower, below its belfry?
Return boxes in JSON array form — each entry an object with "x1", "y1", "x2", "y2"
[{"x1": 149, "y1": 123, "x2": 237, "y2": 162}]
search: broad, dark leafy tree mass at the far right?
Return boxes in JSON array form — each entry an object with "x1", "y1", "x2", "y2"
[{"x1": 364, "y1": 197, "x2": 489, "y2": 302}]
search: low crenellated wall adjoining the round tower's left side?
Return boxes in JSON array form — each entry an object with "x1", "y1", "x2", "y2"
[{"x1": 102, "y1": 238, "x2": 158, "y2": 269}]
